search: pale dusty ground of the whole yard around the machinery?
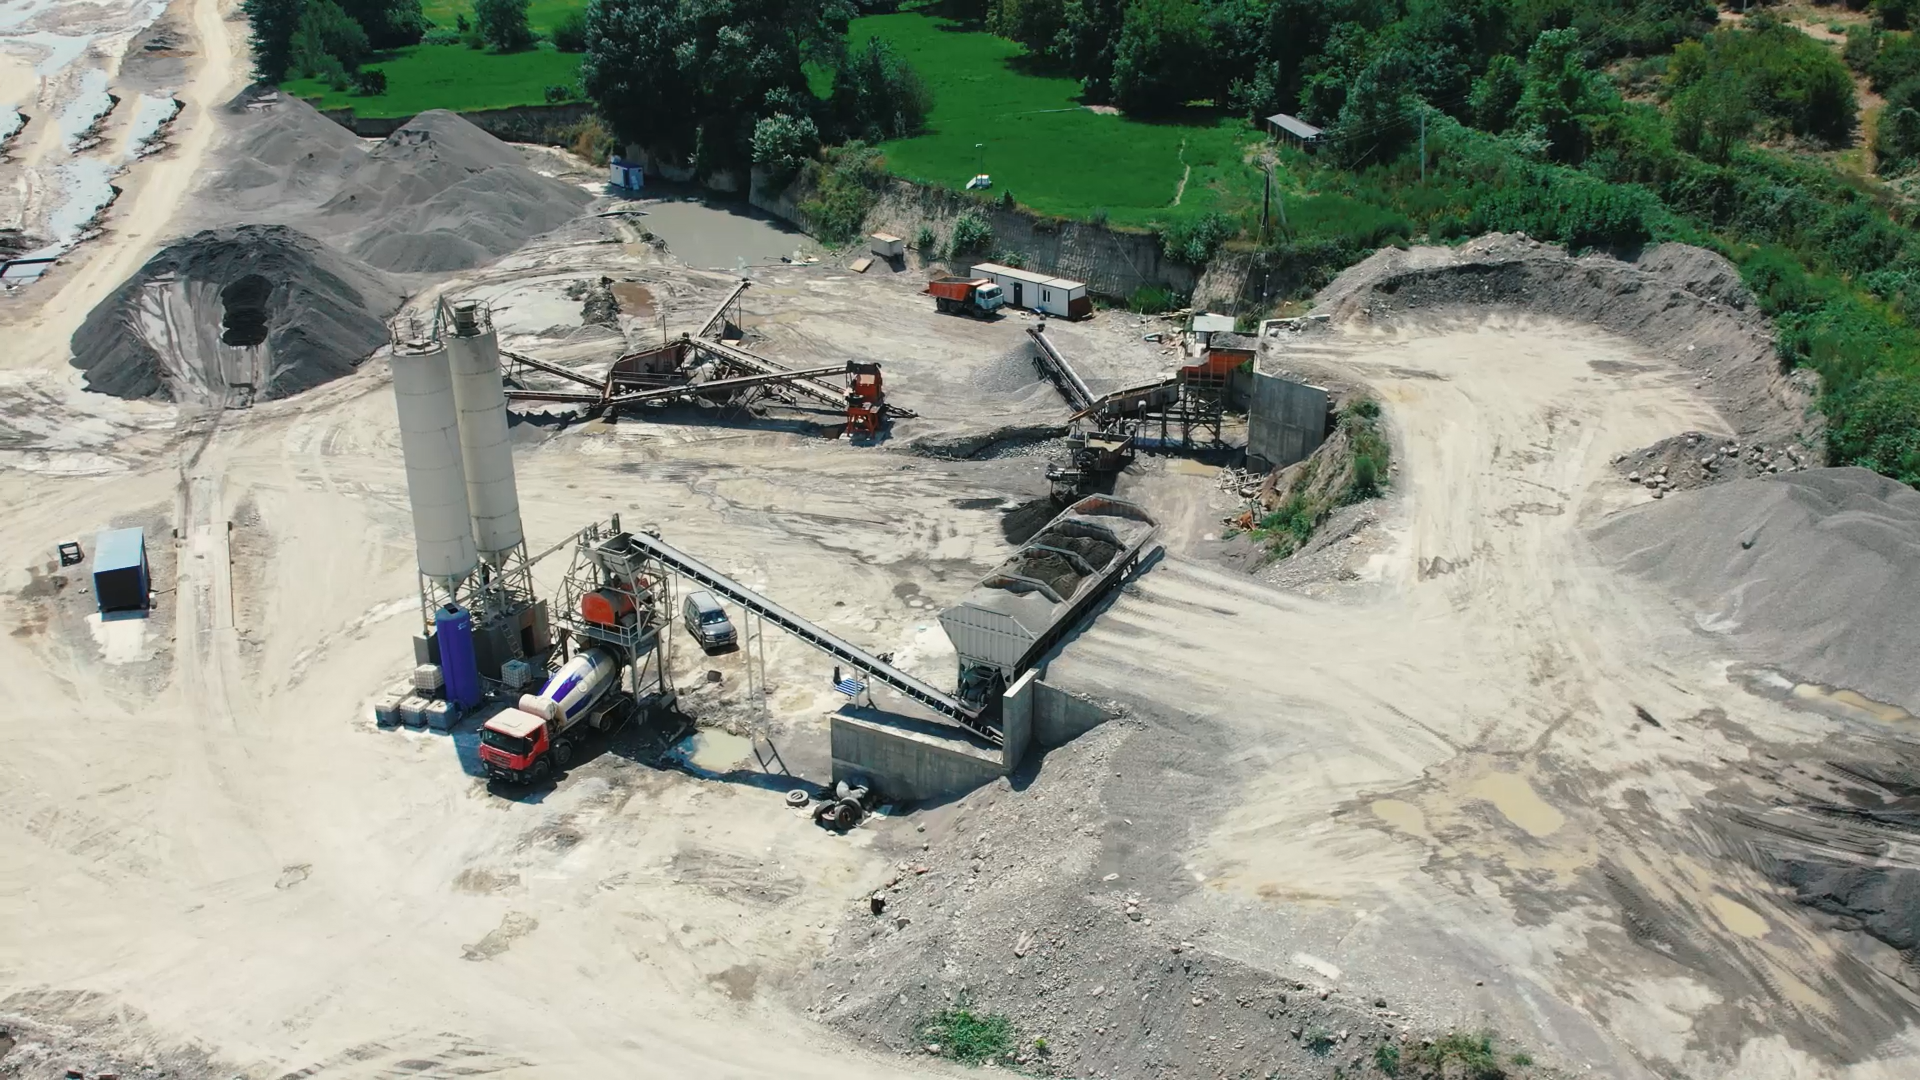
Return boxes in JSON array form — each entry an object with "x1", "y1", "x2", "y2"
[{"x1": 0, "y1": 10, "x2": 1920, "y2": 1080}]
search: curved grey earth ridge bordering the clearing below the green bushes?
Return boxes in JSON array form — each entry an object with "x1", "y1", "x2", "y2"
[{"x1": 1317, "y1": 233, "x2": 1818, "y2": 444}]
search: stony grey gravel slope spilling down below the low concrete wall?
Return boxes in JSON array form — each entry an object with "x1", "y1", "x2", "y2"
[{"x1": 795, "y1": 721, "x2": 1536, "y2": 1080}]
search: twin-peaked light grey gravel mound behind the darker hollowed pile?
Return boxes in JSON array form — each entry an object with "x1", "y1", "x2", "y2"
[{"x1": 207, "y1": 95, "x2": 593, "y2": 273}]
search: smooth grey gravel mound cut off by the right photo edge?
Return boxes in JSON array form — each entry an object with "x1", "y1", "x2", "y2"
[{"x1": 1594, "y1": 469, "x2": 1920, "y2": 713}]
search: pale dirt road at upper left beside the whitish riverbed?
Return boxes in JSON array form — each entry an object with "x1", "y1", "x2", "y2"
[{"x1": 0, "y1": 0, "x2": 246, "y2": 369}]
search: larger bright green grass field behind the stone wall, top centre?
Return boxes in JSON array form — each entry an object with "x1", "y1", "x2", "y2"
[{"x1": 849, "y1": 13, "x2": 1261, "y2": 227}]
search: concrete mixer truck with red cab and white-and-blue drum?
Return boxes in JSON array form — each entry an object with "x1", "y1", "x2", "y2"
[{"x1": 480, "y1": 638, "x2": 634, "y2": 784}]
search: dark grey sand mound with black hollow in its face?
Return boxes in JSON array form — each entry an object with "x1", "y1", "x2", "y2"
[{"x1": 73, "y1": 225, "x2": 403, "y2": 405}]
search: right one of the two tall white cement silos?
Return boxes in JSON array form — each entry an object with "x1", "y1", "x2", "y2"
[{"x1": 442, "y1": 300, "x2": 524, "y2": 565}]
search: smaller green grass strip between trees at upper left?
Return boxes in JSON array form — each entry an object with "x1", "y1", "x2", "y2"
[{"x1": 280, "y1": 44, "x2": 580, "y2": 117}]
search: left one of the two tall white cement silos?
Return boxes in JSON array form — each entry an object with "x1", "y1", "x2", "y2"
[{"x1": 392, "y1": 342, "x2": 478, "y2": 590}]
